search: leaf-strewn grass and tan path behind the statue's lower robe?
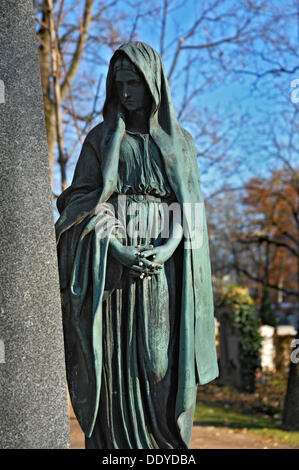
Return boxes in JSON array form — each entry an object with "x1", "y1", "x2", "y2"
[{"x1": 70, "y1": 372, "x2": 299, "y2": 449}]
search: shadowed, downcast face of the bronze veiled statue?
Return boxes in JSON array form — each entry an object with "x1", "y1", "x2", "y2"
[{"x1": 115, "y1": 69, "x2": 151, "y2": 112}]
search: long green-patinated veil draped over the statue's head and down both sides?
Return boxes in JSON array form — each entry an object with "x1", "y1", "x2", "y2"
[{"x1": 56, "y1": 42, "x2": 218, "y2": 447}]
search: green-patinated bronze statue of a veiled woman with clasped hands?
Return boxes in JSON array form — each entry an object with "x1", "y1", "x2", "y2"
[{"x1": 56, "y1": 42, "x2": 218, "y2": 449}]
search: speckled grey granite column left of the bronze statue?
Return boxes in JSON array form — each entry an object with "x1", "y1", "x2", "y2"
[{"x1": 0, "y1": 0, "x2": 69, "y2": 449}]
